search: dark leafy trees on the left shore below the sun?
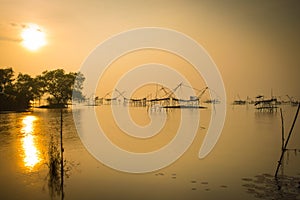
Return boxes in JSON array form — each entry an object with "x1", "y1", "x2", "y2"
[{"x1": 0, "y1": 68, "x2": 85, "y2": 111}]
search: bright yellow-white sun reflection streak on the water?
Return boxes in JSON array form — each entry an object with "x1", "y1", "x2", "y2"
[{"x1": 21, "y1": 116, "x2": 41, "y2": 169}]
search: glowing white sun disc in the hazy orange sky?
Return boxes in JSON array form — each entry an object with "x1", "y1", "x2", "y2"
[{"x1": 21, "y1": 24, "x2": 47, "y2": 51}]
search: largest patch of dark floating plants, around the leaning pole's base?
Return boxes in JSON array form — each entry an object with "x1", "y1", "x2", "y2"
[{"x1": 242, "y1": 174, "x2": 300, "y2": 200}]
